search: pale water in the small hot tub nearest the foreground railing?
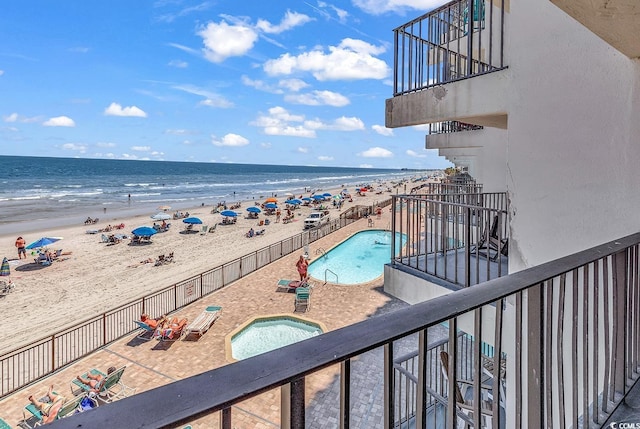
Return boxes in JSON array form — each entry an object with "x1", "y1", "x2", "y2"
[{"x1": 231, "y1": 317, "x2": 323, "y2": 360}]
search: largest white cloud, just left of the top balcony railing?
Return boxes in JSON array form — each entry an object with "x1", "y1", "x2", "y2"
[{"x1": 263, "y1": 39, "x2": 391, "y2": 81}]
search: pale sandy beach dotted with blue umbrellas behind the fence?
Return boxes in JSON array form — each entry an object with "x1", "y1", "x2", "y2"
[{"x1": 0, "y1": 186, "x2": 398, "y2": 354}]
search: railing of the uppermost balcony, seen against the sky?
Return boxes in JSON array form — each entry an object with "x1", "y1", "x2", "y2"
[{"x1": 393, "y1": 0, "x2": 506, "y2": 96}]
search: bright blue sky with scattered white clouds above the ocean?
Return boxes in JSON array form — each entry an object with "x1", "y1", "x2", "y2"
[{"x1": 0, "y1": 0, "x2": 450, "y2": 168}]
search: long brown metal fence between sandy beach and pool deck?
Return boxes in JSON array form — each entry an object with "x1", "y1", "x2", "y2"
[{"x1": 0, "y1": 199, "x2": 391, "y2": 398}]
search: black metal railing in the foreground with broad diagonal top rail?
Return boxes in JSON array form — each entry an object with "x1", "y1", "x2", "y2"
[{"x1": 51, "y1": 233, "x2": 640, "y2": 429}]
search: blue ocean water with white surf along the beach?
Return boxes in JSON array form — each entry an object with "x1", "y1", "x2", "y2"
[{"x1": 0, "y1": 156, "x2": 420, "y2": 233}]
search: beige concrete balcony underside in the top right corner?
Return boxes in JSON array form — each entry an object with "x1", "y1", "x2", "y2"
[{"x1": 551, "y1": 0, "x2": 640, "y2": 58}]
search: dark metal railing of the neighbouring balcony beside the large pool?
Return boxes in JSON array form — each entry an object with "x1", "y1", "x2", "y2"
[{"x1": 391, "y1": 193, "x2": 509, "y2": 287}]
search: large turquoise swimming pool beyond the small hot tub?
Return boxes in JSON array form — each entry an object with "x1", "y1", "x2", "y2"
[{"x1": 308, "y1": 229, "x2": 406, "y2": 284}]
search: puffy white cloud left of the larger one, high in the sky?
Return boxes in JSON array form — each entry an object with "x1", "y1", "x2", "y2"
[{"x1": 197, "y1": 21, "x2": 258, "y2": 63}]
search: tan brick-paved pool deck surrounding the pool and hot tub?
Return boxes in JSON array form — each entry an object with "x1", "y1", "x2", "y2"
[{"x1": 0, "y1": 209, "x2": 413, "y2": 429}]
